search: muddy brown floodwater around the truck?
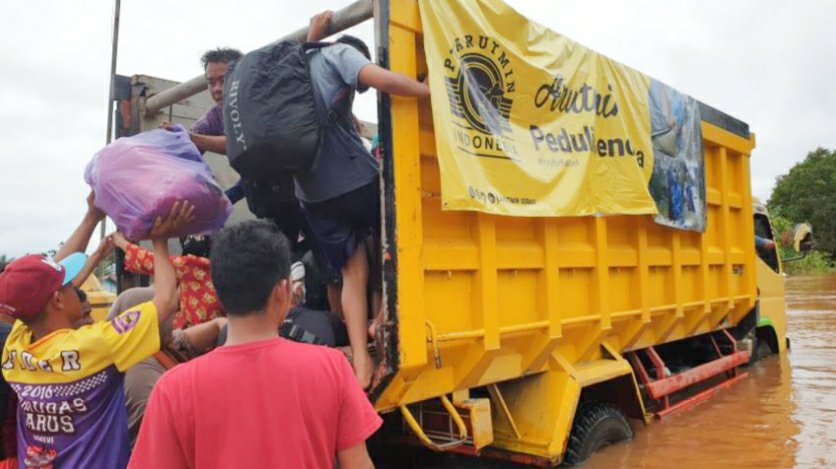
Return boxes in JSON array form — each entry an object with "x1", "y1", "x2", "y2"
[{"x1": 381, "y1": 275, "x2": 836, "y2": 469}]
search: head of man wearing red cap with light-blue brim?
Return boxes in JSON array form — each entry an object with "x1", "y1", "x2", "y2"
[{"x1": 0, "y1": 253, "x2": 87, "y2": 327}]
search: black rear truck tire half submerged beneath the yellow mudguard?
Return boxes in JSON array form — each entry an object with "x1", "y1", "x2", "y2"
[{"x1": 563, "y1": 402, "x2": 633, "y2": 466}]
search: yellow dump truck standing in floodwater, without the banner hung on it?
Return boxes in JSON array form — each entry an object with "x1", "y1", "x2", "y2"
[{"x1": 371, "y1": 0, "x2": 786, "y2": 465}]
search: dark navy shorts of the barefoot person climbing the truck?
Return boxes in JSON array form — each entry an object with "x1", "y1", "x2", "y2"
[{"x1": 302, "y1": 179, "x2": 380, "y2": 270}]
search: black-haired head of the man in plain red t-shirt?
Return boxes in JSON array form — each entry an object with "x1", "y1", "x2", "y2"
[{"x1": 210, "y1": 220, "x2": 291, "y2": 326}]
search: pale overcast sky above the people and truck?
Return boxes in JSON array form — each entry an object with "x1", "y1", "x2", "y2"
[{"x1": 0, "y1": 0, "x2": 836, "y2": 256}]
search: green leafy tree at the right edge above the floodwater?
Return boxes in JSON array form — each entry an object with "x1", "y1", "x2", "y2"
[{"x1": 768, "y1": 148, "x2": 836, "y2": 259}]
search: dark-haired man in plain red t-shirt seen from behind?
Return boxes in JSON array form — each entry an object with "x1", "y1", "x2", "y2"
[{"x1": 129, "y1": 220, "x2": 382, "y2": 469}]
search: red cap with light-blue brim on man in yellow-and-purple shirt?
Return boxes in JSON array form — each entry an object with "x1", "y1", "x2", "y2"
[{"x1": 0, "y1": 252, "x2": 87, "y2": 320}]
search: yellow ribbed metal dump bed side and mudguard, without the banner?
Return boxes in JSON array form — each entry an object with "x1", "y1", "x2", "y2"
[{"x1": 375, "y1": 0, "x2": 756, "y2": 461}]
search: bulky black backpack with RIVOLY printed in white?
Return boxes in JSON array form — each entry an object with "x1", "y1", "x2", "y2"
[{"x1": 223, "y1": 41, "x2": 330, "y2": 181}]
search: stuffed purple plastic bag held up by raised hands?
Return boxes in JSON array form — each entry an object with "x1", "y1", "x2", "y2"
[{"x1": 84, "y1": 125, "x2": 232, "y2": 240}]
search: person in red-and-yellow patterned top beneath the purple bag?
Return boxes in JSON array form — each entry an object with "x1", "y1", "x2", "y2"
[{"x1": 113, "y1": 232, "x2": 224, "y2": 329}]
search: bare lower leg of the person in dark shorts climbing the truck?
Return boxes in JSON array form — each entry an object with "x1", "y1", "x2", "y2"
[{"x1": 342, "y1": 243, "x2": 374, "y2": 389}]
